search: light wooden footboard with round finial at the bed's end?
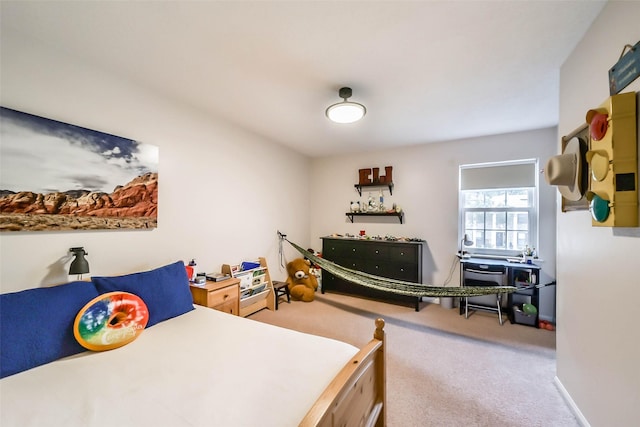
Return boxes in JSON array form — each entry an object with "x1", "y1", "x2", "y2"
[{"x1": 300, "y1": 319, "x2": 387, "y2": 427}]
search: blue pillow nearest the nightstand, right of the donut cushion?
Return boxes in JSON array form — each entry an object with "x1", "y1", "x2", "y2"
[{"x1": 91, "y1": 261, "x2": 193, "y2": 328}]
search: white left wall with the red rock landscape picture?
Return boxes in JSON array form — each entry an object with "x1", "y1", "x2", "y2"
[{"x1": 0, "y1": 29, "x2": 310, "y2": 292}]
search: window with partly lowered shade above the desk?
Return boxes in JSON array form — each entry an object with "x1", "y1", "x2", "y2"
[{"x1": 459, "y1": 160, "x2": 538, "y2": 256}]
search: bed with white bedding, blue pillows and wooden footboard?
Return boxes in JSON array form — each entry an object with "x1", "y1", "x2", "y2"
[{"x1": 0, "y1": 262, "x2": 386, "y2": 427}]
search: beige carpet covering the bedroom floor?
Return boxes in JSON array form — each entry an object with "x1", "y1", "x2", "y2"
[{"x1": 249, "y1": 293, "x2": 580, "y2": 427}]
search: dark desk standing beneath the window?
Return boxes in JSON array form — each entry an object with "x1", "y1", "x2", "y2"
[{"x1": 459, "y1": 258, "x2": 541, "y2": 327}]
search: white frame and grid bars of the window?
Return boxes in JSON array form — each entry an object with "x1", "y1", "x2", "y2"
[{"x1": 458, "y1": 159, "x2": 540, "y2": 258}]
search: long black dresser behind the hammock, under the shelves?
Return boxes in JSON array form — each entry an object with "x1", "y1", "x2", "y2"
[{"x1": 322, "y1": 237, "x2": 423, "y2": 311}]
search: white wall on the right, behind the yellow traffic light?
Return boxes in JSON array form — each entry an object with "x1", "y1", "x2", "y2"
[{"x1": 556, "y1": 1, "x2": 640, "y2": 426}]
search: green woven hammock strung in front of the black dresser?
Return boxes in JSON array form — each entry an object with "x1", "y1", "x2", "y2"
[{"x1": 278, "y1": 232, "x2": 516, "y2": 298}]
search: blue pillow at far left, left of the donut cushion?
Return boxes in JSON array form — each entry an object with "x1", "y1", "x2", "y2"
[{"x1": 0, "y1": 282, "x2": 98, "y2": 378}]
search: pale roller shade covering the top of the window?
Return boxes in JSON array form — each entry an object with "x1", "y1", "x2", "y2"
[{"x1": 460, "y1": 161, "x2": 536, "y2": 190}]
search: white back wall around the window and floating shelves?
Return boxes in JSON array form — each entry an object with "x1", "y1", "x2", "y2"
[{"x1": 311, "y1": 128, "x2": 557, "y2": 320}]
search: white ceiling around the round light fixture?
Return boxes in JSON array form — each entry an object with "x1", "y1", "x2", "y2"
[{"x1": 1, "y1": 0, "x2": 605, "y2": 157}]
